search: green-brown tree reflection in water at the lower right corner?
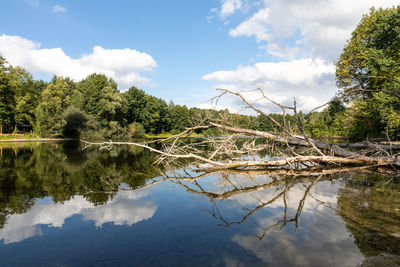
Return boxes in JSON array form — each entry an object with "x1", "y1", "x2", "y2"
[{"x1": 338, "y1": 174, "x2": 400, "y2": 257}]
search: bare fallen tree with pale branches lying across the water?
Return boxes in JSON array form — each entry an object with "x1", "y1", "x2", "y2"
[{"x1": 83, "y1": 89, "x2": 400, "y2": 172}]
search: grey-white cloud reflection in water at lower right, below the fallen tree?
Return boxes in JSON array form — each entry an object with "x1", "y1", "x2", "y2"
[{"x1": 222, "y1": 181, "x2": 364, "y2": 266}]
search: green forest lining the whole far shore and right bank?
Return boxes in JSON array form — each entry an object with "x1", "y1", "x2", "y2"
[{"x1": 0, "y1": 6, "x2": 400, "y2": 140}]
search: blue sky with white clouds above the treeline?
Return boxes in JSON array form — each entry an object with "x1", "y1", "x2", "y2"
[{"x1": 0, "y1": 0, "x2": 396, "y2": 111}]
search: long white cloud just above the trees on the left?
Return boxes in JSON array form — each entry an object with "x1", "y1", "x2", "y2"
[{"x1": 0, "y1": 34, "x2": 157, "y2": 89}]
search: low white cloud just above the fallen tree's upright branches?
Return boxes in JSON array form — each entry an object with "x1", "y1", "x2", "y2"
[{"x1": 203, "y1": 58, "x2": 337, "y2": 112}]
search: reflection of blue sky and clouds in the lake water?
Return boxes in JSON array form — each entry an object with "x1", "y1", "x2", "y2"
[{"x1": 0, "y1": 176, "x2": 363, "y2": 266}]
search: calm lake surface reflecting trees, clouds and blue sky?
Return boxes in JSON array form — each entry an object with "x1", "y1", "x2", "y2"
[{"x1": 0, "y1": 142, "x2": 400, "y2": 266}]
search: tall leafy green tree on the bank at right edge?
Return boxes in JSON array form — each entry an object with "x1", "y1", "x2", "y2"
[{"x1": 336, "y1": 6, "x2": 400, "y2": 136}]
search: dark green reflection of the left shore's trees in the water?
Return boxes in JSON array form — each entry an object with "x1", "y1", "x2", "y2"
[{"x1": 0, "y1": 142, "x2": 158, "y2": 228}]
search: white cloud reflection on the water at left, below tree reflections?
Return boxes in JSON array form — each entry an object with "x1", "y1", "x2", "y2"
[{"x1": 0, "y1": 190, "x2": 157, "y2": 244}]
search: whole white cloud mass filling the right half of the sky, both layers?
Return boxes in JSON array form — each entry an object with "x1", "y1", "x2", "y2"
[{"x1": 208, "y1": 0, "x2": 398, "y2": 112}]
